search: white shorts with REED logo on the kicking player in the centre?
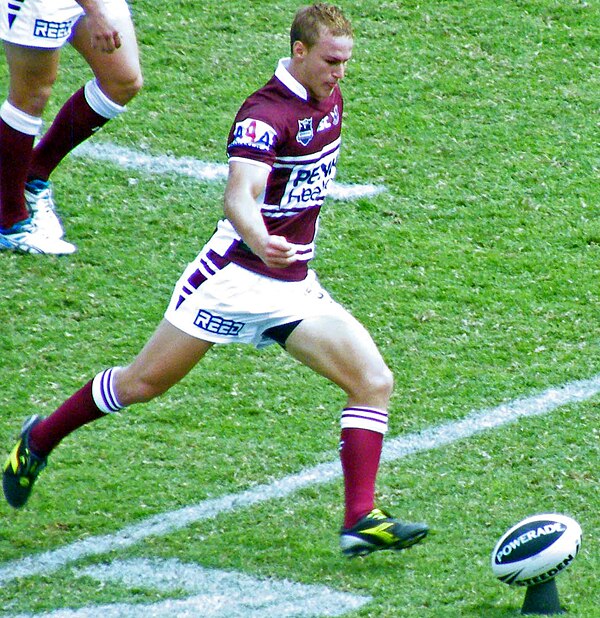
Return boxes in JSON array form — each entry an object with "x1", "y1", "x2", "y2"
[{"x1": 165, "y1": 254, "x2": 349, "y2": 348}]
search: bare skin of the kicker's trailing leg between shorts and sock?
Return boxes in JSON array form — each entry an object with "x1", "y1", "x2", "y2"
[{"x1": 117, "y1": 320, "x2": 213, "y2": 405}]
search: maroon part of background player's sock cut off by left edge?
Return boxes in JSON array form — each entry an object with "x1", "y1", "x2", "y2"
[{"x1": 0, "y1": 118, "x2": 34, "y2": 228}]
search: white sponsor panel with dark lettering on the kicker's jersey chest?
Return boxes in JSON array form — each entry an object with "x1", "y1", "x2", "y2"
[{"x1": 281, "y1": 149, "x2": 338, "y2": 208}]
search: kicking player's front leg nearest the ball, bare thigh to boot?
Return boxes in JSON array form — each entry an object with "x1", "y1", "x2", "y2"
[{"x1": 285, "y1": 314, "x2": 428, "y2": 557}]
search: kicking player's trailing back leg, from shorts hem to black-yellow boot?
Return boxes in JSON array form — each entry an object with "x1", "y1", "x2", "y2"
[{"x1": 3, "y1": 321, "x2": 212, "y2": 508}]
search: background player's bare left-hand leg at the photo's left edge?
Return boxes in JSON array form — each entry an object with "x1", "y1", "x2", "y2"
[{"x1": 4, "y1": 42, "x2": 60, "y2": 117}]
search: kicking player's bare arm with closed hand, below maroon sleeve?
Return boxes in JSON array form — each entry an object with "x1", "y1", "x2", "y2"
[{"x1": 223, "y1": 161, "x2": 298, "y2": 268}]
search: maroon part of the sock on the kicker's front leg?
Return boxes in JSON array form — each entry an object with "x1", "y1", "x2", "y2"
[{"x1": 340, "y1": 428, "x2": 383, "y2": 528}]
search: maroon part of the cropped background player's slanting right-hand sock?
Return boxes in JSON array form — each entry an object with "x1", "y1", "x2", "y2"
[{"x1": 29, "y1": 88, "x2": 108, "y2": 180}]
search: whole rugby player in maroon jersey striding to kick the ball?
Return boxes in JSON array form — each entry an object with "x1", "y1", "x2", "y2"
[{"x1": 3, "y1": 3, "x2": 428, "y2": 557}]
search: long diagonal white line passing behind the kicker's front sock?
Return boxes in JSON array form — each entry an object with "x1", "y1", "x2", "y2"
[{"x1": 0, "y1": 375, "x2": 600, "y2": 584}]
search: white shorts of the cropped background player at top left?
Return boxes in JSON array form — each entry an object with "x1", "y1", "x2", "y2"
[{"x1": 0, "y1": 0, "x2": 129, "y2": 49}]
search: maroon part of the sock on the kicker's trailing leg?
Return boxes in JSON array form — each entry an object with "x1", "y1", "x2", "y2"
[{"x1": 29, "y1": 380, "x2": 106, "y2": 457}]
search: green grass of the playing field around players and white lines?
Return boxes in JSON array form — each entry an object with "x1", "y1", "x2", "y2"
[{"x1": 0, "y1": 0, "x2": 600, "y2": 618}]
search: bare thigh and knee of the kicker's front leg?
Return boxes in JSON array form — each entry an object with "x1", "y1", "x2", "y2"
[{"x1": 286, "y1": 313, "x2": 393, "y2": 406}]
